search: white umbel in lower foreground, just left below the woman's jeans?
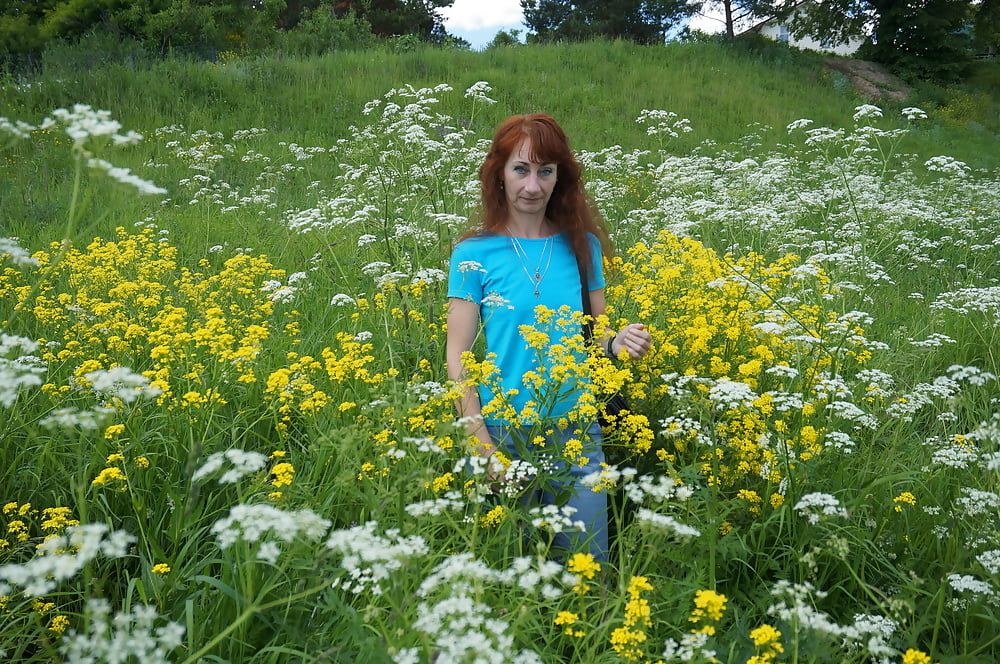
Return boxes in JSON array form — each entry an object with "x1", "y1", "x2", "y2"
[{"x1": 326, "y1": 521, "x2": 429, "y2": 595}]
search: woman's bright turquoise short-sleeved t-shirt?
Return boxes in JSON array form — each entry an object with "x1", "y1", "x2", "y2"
[{"x1": 448, "y1": 228, "x2": 604, "y2": 424}]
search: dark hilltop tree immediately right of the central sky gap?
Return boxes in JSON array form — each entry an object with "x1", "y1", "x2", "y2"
[{"x1": 521, "y1": 0, "x2": 696, "y2": 44}]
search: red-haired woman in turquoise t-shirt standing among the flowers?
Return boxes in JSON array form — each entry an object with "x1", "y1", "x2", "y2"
[{"x1": 446, "y1": 114, "x2": 650, "y2": 560}]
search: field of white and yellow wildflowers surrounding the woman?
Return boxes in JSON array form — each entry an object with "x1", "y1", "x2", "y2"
[{"x1": 0, "y1": 44, "x2": 1000, "y2": 664}]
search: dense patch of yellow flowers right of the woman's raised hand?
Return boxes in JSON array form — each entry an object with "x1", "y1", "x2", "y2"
[{"x1": 607, "y1": 231, "x2": 871, "y2": 487}]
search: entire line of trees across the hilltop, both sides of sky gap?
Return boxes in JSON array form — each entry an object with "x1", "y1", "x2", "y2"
[{"x1": 0, "y1": 0, "x2": 1000, "y2": 78}]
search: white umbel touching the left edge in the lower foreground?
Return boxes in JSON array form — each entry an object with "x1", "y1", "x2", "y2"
[{"x1": 0, "y1": 523, "x2": 136, "y2": 597}]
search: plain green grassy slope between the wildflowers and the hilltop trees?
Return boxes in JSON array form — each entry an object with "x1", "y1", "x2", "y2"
[{"x1": 0, "y1": 42, "x2": 1000, "y2": 160}]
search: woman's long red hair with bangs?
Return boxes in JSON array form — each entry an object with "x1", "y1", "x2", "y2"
[{"x1": 463, "y1": 113, "x2": 614, "y2": 272}]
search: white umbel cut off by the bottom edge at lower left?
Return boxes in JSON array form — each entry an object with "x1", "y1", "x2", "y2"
[{"x1": 59, "y1": 599, "x2": 184, "y2": 664}]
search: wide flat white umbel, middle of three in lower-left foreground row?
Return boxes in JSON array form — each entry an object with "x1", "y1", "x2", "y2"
[{"x1": 212, "y1": 504, "x2": 330, "y2": 563}]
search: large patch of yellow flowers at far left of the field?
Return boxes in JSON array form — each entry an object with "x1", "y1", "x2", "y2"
[{"x1": 0, "y1": 228, "x2": 284, "y2": 408}]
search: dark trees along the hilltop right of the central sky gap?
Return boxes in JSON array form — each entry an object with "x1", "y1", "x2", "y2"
[{"x1": 521, "y1": 0, "x2": 1000, "y2": 78}]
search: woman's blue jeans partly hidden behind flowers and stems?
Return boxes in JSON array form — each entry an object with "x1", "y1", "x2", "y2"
[{"x1": 486, "y1": 422, "x2": 608, "y2": 563}]
